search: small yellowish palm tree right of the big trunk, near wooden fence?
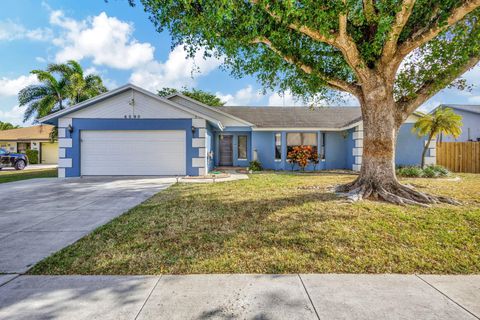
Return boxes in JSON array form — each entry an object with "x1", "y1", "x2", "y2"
[{"x1": 412, "y1": 108, "x2": 463, "y2": 168}]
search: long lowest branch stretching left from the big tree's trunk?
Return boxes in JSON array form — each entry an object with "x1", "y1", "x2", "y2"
[{"x1": 252, "y1": 37, "x2": 361, "y2": 97}]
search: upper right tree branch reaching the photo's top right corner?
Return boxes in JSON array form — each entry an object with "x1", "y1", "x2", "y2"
[{"x1": 396, "y1": 0, "x2": 480, "y2": 60}]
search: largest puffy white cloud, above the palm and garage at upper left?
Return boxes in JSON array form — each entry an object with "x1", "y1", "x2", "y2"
[{"x1": 50, "y1": 10, "x2": 155, "y2": 70}]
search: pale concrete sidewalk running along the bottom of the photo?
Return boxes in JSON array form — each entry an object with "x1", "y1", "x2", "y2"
[{"x1": 0, "y1": 274, "x2": 480, "y2": 320}]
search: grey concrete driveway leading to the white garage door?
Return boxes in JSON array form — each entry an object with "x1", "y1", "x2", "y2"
[{"x1": 0, "y1": 177, "x2": 175, "y2": 273}]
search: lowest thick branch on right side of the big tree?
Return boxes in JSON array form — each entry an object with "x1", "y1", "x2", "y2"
[{"x1": 397, "y1": 56, "x2": 480, "y2": 117}]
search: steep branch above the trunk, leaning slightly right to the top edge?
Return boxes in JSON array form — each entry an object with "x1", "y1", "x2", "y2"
[{"x1": 381, "y1": 0, "x2": 416, "y2": 62}]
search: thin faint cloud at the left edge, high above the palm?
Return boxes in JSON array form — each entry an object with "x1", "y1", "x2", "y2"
[{"x1": 0, "y1": 20, "x2": 52, "y2": 41}]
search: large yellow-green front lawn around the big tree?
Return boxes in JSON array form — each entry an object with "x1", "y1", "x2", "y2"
[{"x1": 30, "y1": 174, "x2": 480, "y2": 274}]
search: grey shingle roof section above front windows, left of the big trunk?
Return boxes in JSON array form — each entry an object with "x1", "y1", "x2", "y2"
[{"x1": 218, "y1": 107, "x2": 362, "y2": 130}]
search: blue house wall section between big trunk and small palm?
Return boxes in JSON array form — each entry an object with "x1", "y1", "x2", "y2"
[{"x1": 395, "y1": 123, "x2": 429, "y2": 167}]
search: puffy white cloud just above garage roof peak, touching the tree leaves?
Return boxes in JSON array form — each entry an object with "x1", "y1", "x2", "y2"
[{"x1": 130, "y1": 46, "x2": 221, "y2": 91}]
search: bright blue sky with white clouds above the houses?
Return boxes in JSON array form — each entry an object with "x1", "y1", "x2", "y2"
[{"x1": 0, "y1": 0, "x2": 480, "y2": 125}]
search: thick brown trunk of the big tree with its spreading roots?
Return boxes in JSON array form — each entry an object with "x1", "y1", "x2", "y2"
[{"x1": 337, "y1": 82, "x2": 457, "y2": 205}]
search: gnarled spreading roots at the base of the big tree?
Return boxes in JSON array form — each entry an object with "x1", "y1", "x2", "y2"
[{"x1": 335, "y1": 179, "x2": 460, "y2": 207}]
